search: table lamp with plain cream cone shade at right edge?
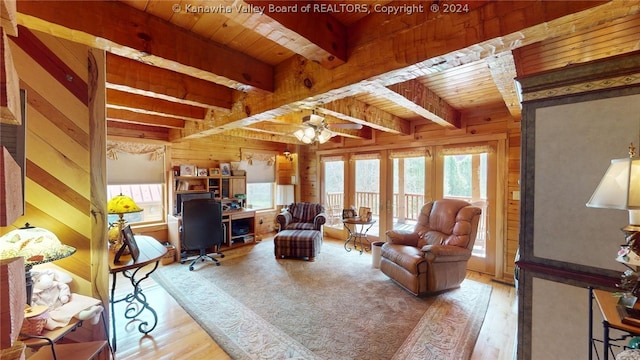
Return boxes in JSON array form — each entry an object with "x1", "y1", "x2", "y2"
[{"x1": 587, "y1": 143, "x2": 640, "y2": 265}]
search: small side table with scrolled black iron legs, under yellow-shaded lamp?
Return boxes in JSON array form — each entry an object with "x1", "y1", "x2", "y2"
[{"x1": 109, "y1": 235, "x2": 167, "y2": 352}]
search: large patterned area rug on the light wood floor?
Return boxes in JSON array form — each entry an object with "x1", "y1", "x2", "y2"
[{"x1": 153, "y1": 241, "x2": 491, "y2": 359}]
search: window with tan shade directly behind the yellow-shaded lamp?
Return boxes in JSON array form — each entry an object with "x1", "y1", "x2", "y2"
[{"x1": 107, "y1": 141, "x2": 166, "y2": 224}]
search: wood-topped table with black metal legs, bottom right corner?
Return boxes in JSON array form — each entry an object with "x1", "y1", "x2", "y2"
[{"x1": 589, "y1": 288, "x2": 640, "y2": 360}]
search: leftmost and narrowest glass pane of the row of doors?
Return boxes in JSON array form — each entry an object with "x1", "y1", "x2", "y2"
[{"x1": 324, "y1": 161, "x2": 344, "y2": 228}]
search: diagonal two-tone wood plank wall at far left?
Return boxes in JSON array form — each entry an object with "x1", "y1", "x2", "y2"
[{"x1": 3, "y1": 30, "x2": 93, "y2": 295}]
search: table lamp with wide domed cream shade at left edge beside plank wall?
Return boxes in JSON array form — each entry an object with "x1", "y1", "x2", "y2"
[{"x1": 0, "y1": 223, "x2": 76, "y2": 305}]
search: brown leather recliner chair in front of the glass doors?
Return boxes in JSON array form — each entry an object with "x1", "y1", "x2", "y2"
[{"x1": 380, "y1": 199, "x2": 482, "y2": 296}]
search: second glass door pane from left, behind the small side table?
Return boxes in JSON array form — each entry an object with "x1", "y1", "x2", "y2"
[{"x1": 355, "y1": 159, "x2": 380, "y2": 236}]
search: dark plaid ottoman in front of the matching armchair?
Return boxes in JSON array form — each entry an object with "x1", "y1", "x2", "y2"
[{"x1": 273, "y1": 230, "x2": 322, "y2": 261}]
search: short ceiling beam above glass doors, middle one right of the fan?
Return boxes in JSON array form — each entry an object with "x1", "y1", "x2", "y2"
[{"x1": 373, "y1": 79, "x2": 460, "y2": 129}]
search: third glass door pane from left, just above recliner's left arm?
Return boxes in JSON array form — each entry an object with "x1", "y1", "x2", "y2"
[{"x1": 393, "y1": 156, "x2": 426, "y2": 230}]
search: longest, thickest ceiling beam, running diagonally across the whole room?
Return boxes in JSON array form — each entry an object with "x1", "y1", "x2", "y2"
[{"x1": 170, "y1": 1, "x2": 616, "y2": 141}]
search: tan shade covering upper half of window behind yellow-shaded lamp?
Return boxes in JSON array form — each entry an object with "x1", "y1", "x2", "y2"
[{"x1": 107, "y1": 141, "x2": 165, "y2": 185}]
